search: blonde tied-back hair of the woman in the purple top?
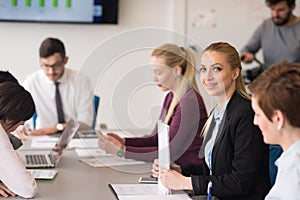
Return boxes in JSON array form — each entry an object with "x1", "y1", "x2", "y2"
[{"x1": 151, "y1": 43, "x2": 199, "y2": 93}]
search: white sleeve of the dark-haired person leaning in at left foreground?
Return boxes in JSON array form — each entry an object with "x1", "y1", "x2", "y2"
[{"x1": 0, "y1": 124, "x2": 37, "y2": 198}]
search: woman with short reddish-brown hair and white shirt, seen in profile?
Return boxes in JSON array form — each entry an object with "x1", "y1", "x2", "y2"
[{"x1": 249, "y1": 62, "x2": 300, "y2": 200}]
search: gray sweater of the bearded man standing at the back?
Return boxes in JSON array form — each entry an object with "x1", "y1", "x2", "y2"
[{"x1": 241, "y1": 18, "x2": 300, "y2": 66}]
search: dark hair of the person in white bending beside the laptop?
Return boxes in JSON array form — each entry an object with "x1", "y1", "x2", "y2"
[{"x1": 0, "y1": 82, "x2": 35, "y2": 129}]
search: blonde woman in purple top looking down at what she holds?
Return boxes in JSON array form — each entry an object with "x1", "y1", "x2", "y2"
[{"x1": 99, "y1": 44, "x2": 207, "y2": 164}]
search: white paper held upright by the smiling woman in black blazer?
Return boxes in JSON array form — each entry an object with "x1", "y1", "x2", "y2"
[{"x1": 157, "y1": 121, "x2": 171, "y2": 194}]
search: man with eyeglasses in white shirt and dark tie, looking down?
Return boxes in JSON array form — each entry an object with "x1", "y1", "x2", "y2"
[{"x1": 21, "y1": 38, "x2": 93, "y2": 135}]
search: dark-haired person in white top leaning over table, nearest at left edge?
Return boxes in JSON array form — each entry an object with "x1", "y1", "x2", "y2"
[{"x1": 0, "y1": 82, "x2": 37, "y2": 198}]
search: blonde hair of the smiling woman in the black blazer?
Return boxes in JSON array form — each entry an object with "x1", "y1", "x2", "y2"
[{"x1": 204, "y1": 42, "x2": 250, "y2": 99}]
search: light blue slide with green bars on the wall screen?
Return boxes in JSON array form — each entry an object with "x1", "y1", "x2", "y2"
[{"x1": 0, "y1": 0, "x2": 102, "y2": 23}]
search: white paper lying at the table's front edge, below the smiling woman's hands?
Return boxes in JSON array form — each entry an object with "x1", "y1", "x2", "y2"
[{"x1": 109, "y1": 184, "x2": 191, "y2": 200}]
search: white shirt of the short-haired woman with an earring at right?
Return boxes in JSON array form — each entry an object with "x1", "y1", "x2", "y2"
[{"x1": 265, "y1": 140, "x2": 300, "y2": 200}]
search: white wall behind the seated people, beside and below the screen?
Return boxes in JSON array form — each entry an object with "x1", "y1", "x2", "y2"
[{"x1": 0, "y1": 0, "x2": 300, "y2": 129}]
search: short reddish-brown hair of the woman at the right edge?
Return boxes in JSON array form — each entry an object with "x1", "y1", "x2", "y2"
[{"x1": 248, "y1": 61, "x2": 300, "y2": 127}]
